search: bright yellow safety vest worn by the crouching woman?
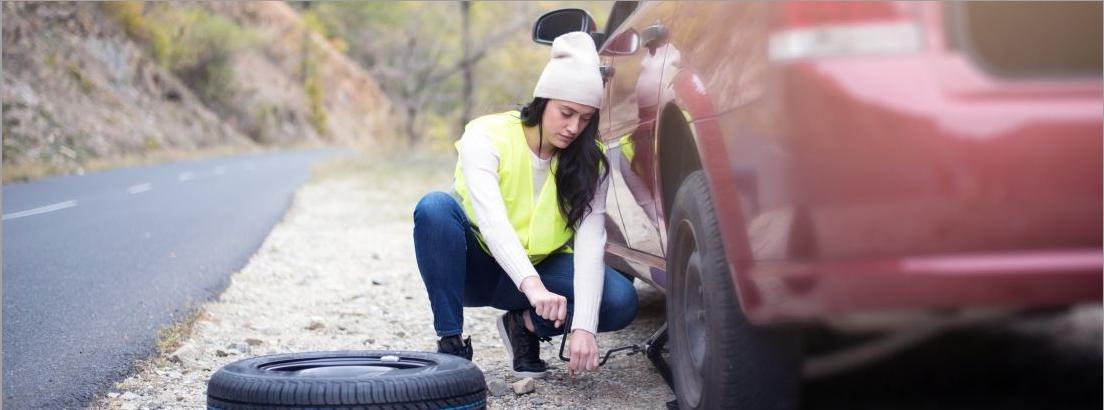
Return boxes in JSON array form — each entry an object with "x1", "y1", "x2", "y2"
[{"x1": 453, "y1": 111, "x2": 574, "y2": 264}]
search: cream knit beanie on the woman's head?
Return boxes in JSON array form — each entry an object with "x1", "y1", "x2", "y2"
[{"x1": 533, "y1": 31, "x2": 602, "y2": 108}]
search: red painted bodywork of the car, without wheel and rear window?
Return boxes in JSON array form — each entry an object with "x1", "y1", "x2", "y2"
[{"x1": 603, "y1": 2, "x2": 1104, "y2": 323}]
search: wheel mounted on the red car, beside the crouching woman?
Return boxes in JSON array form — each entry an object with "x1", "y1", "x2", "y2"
[{"x1": 667, "y1": 170, "x2": 800, "y2": 409}]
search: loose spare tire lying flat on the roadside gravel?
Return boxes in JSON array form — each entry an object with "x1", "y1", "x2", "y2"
[{"x1": 208, "y1": 350, "x2": 487, "y2": 410}]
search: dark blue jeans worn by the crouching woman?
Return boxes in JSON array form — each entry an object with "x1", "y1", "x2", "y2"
[{"x1": 414, "y1": 192, "x2": 637, "y2": 337}]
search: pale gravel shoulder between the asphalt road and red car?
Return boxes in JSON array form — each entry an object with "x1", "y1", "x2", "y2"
[{"x1": 89, "y1": 155, "x2": 673, "y2": 409}]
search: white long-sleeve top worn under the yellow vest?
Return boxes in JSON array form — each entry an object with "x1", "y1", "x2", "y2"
[{"x1": 459, "y1": 130, "x2": 608, "y2": 335}]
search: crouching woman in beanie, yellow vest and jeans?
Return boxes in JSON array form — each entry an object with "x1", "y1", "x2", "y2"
[{"x1": 414, "y1": 32, "x2": 637, "y2": 377}]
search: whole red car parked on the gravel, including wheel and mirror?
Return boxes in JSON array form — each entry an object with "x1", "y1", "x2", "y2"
[{"x1": 533, "y1": 1, "x2": 1104, "y2": 409}]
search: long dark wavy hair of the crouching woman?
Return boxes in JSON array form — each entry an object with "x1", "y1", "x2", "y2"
[{"x1": 521, "y1": 97, "x2": 609, "y2": 231}]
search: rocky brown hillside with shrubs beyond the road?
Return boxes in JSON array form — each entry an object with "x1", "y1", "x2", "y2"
[{"x1": 0, "y1": 2, "x2": 390, "y2": 182}]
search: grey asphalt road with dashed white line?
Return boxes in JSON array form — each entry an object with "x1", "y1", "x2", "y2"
[{"x1": 2, "y1": 150, "x2": 340, "y2": 409}]
